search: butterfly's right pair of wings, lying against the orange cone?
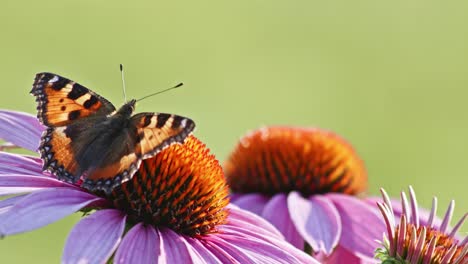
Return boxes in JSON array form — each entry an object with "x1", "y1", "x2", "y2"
[{"x1": 82, "y1": 113, "x2": 195, "y2": 193}]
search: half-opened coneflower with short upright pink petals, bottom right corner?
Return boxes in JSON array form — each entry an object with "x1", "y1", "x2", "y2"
[{"x1": 377, "y1": 186, "x2": 468, "y2": 264}]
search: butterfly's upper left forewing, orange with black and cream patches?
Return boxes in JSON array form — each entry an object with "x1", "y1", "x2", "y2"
[{"x1": 31, "y1": 73, "x2": 115, "y2": 126}]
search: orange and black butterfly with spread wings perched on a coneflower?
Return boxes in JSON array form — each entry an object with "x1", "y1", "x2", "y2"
[{"x1": 31, "y1": 72, "x2": 195, "y2": 193}]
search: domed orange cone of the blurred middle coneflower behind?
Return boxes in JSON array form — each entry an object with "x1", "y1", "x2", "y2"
[{"x1": 224, "y1": 127, "x2": 367, "y2": 196}]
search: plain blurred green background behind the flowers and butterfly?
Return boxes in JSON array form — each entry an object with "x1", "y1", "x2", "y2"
[{"x1": 0, "y1": 0, "x2": 468, "y2": 263}]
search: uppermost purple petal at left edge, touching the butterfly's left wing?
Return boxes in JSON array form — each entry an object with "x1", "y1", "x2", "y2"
[{"x1": 0, "y1": 110, "x2": 44, "y2": 151}]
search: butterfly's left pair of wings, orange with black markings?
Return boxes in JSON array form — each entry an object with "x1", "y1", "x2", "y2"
[{"x1": 31, "y1": 73, "x2": 115, "y2": 182}]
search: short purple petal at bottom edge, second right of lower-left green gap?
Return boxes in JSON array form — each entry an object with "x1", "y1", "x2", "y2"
[{"x1": 114, "y1": 223, "x2": 161, "y2": 264}]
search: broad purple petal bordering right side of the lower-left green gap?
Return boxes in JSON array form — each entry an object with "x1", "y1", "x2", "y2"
[{"x1": 62, "y1": 209, "x2": 127, "y2": 264}]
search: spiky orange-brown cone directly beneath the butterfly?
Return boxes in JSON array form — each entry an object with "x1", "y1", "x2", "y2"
[{"x1": 107, "y1": 136, "x2": 229, "y2": 236}]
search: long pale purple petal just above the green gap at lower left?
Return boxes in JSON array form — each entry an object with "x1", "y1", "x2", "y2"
[{"x1": 0, "y1": 187, "x2": 101, "y2": 235}]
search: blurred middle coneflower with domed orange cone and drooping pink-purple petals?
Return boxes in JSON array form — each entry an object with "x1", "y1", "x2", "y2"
[{"x1": 224, "y1": 127, "x2": 385, "y2": 263}]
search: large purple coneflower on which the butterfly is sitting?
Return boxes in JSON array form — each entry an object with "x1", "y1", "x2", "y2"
[{"x1": 0, "y1": 111, "x2": 317, "y2": 263}]
